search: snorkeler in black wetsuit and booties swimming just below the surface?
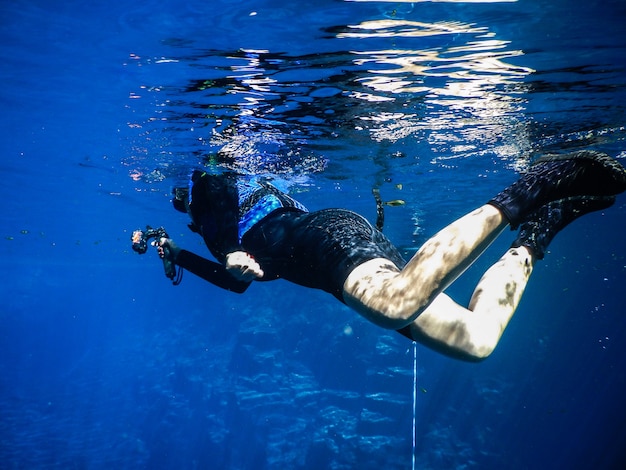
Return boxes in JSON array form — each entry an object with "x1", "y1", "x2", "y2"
[{"x1": 152, "y1": 151, "x2": 626, "y2": 360}]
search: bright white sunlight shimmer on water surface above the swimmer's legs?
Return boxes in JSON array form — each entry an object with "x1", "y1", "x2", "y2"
[{"x1": 337, "y1": 17, "x2": 534, "y2": 154}]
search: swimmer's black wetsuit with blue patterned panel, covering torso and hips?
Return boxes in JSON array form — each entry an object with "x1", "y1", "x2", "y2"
[{"x1": 176, "y1": 172, "x2": 405, "y2": 302}]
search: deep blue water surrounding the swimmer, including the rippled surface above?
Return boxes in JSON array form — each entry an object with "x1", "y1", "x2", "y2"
[{"x1": 0, "y1": 0, "x2": 626, "y2": 469}]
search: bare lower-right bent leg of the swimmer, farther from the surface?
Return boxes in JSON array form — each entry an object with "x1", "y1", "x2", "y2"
[{"x1": 410, "y1": 247, "x2": 534, "y2": 360}]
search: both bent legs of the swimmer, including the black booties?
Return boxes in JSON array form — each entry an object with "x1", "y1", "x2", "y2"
[{"x1": 343, "y1": 151, "x2": 626, "y2": 359}]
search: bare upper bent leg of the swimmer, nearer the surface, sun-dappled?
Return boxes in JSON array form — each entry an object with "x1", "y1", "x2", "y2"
[{"x1": 343, "y1": 205, "x2": 507, "y2": 330}]
